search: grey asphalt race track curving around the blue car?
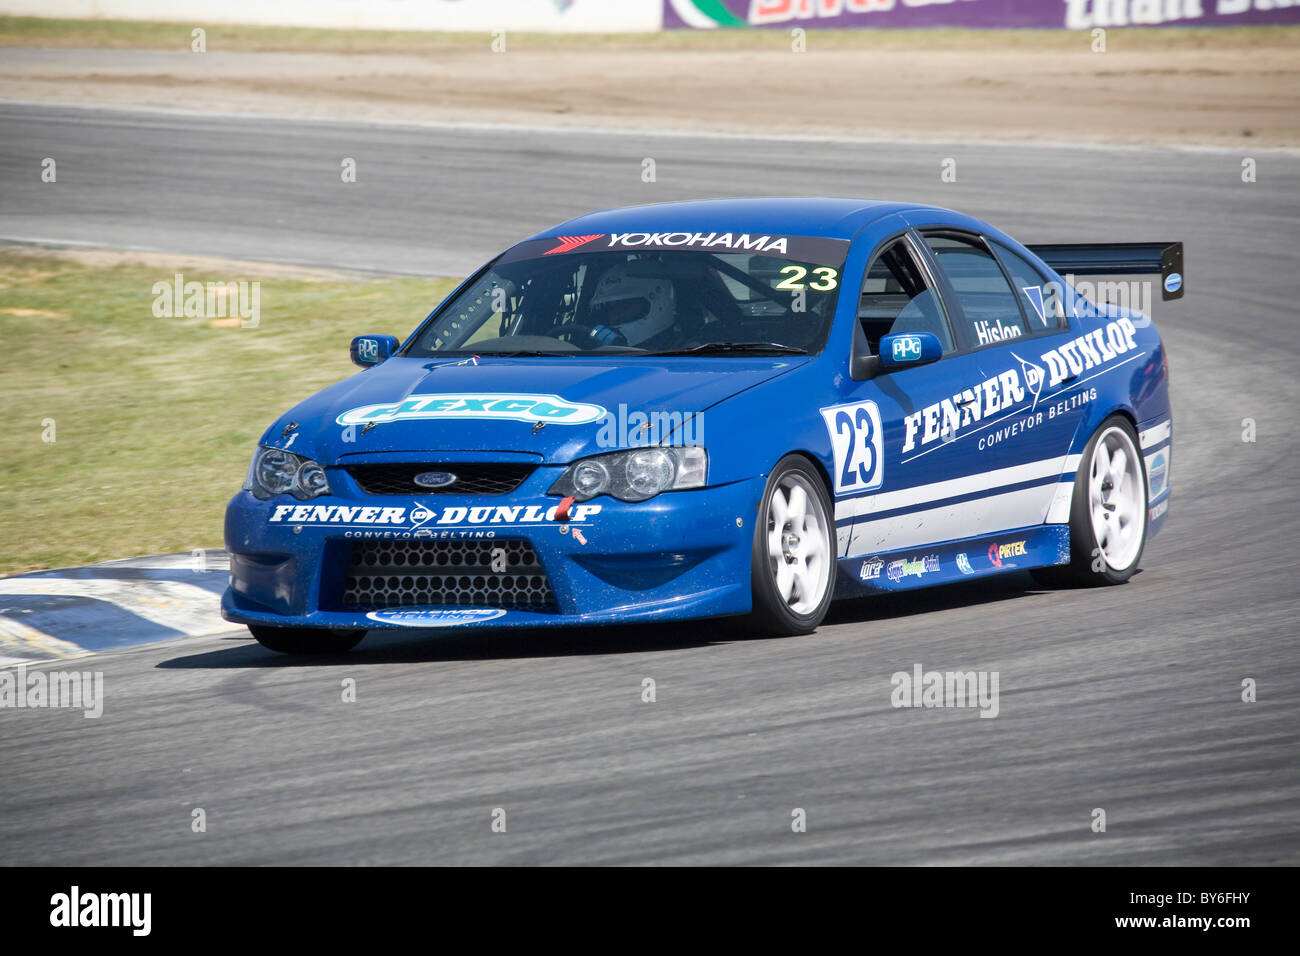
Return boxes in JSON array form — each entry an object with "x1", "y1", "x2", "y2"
[{"x1": 0, "y1": 105, "x2": 1300, "y2": 865}]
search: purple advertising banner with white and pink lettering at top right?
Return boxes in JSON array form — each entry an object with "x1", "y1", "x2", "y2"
[{"x1": 663, "y1": 0, "x2": 1300, "y2": 30}]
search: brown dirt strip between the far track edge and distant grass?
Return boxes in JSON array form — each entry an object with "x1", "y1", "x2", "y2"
[{"x1": 0, "y1": 29, "x2": 1300, "y2": 147}]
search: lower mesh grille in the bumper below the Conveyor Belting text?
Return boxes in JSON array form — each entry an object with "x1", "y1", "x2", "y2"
[{"x1": 343, "y1": 538, "x2": 555, "y2": 611}]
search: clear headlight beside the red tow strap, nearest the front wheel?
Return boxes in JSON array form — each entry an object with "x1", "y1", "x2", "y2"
[{"x1": 549, "y1": 446, "x2": 709, "y2": 501}]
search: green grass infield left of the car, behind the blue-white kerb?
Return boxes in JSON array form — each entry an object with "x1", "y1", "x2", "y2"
[{"x1": 0, "y1": 250, "x2": 452, "y2": 574}]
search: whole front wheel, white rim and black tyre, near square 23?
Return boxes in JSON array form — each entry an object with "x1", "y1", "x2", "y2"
[{"x1": 750, "y1": 455, "x2": 836, "y2": 635}]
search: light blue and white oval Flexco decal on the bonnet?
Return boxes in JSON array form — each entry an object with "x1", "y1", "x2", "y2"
[{"x1": 335, "y1": 393, "x2": 606, "y2": 425}]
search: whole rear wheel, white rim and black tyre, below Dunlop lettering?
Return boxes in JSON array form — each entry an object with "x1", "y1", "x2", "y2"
[{"x1": 1034, "y1": 415, "x2": 1147, "y2": 587}]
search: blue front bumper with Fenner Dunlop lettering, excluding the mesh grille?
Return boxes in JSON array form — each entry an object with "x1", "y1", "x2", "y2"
[{"x1": 221, "y1": 467, "x2": 764, "y2": 630}]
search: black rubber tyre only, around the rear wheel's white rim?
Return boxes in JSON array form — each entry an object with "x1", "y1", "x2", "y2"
[{"x1": 1031, "y1": 415, "x2": 1151, "y2": 588}]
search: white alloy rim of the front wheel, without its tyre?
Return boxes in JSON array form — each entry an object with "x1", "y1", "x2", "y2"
[{"x1": 767, "y1": 471, "x2": 835, "y2": 615}]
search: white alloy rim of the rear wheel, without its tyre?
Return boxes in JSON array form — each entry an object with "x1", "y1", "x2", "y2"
[{"x1": 1088, "y1": 427, "x2": 1147, "y2": 571}]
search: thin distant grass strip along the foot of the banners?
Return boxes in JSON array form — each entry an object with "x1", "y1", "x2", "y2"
[{"x1": 0, "y1": 17, "x2": 1300, "y2": 56}]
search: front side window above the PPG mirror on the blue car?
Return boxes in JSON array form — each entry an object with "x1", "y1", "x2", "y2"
[{"x1": 858, "y1": 239, "x2": 953, "y2": 355}]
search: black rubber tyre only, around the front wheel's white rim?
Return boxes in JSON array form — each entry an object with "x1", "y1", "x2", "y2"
[{"x1": 748, "y1": 455, "x2": 837, "y2": 636}]
